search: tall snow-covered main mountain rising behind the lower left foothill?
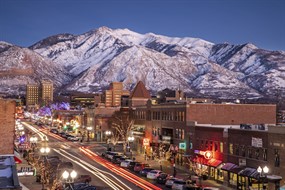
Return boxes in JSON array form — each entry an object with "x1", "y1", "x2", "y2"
[{"x1": 0, "y1": 27, "x2": 285, "y2": 98}]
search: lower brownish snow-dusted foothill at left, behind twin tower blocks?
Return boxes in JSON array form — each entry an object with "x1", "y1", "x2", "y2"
[{"x1": 0, "y1": 45, "x2": 71, "y2": 95}]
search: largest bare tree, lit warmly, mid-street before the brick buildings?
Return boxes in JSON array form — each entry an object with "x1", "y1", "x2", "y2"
[{"x1": 111, "y1": 110, "x2": 134, "y2": 153}]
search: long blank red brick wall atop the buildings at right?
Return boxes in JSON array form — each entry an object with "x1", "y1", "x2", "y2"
[{"x1": 186, "y1": 104, "x2": 276, "y2": 125}]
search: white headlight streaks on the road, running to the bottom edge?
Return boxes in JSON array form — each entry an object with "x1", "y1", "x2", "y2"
[{"x1": 54, "y1": 149, "x2": 132, "y2": 190}]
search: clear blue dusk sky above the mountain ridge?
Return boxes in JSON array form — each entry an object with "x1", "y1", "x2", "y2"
[{"x1": 0, "y1": 0, "x2": 285, "y2": 50}]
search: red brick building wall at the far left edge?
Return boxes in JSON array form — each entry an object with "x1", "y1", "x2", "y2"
[{"x1": 0, "y1": 100, "x2": 16, "y2": 155}]
